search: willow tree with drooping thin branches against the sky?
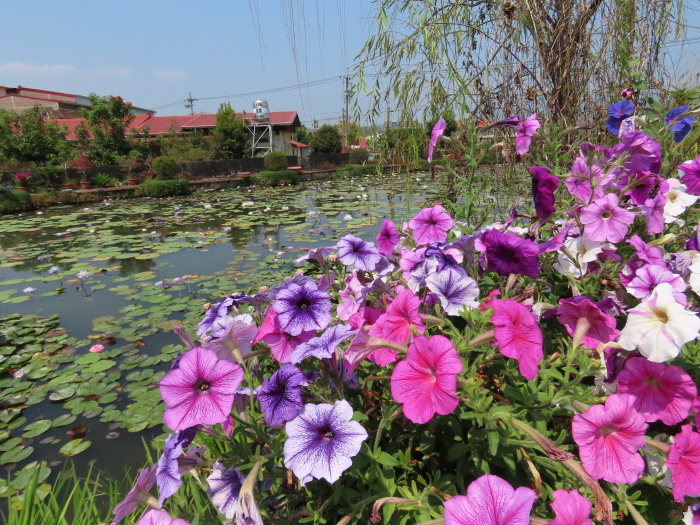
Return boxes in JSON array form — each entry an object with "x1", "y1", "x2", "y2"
[{"x1": 356, "y1": 0, "x2": 683, "y2": 122}]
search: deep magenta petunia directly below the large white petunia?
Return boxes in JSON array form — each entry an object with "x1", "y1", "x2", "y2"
[{"x1": 617, "y1": 357, "x2": 698, "y2": 425}]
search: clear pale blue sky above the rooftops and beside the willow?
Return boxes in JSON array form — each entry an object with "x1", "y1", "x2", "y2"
[{"x1": 0, "y1": 0, "x2": 700, "y2": 127}]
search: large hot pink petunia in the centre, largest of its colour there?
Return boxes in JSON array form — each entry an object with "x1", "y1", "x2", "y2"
[{"x1": 391, "y1": 335, "x2": 462, "y2": 424}]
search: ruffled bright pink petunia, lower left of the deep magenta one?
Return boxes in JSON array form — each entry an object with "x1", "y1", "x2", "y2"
[{"x1": 571, "y1": 394, "x2": 647, "y2": 483}]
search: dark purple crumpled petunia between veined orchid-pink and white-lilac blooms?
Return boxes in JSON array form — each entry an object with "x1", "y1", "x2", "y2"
[{"x1": 256, "y1": 363, "x2": 306, "y2": 427}]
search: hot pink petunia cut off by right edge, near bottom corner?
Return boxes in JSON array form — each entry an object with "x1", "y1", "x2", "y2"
[{"x1": 666, "y1": 425, "x2": 700, "y2": 502}]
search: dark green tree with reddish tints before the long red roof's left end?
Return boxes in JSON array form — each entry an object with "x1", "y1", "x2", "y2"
[{"x1": 77, "y1": 93, "x2": 134, "y2": 165}]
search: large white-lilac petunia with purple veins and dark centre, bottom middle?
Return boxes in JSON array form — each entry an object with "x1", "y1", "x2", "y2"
[{"x1": 284, "y1": 400, "x2": 367, "y2": 483}]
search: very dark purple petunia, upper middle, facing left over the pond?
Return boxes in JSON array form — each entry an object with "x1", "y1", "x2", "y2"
[{"x1": 481, "y1": 230, "x2": 540, "y2": 277}]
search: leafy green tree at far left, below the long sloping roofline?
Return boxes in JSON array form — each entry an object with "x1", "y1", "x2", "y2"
[{"x1": 0, "y1": 105, "x2": 69, "y2": 166}]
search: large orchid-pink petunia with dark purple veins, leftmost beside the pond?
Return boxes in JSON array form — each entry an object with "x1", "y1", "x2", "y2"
[{"x1": 159, "y1": 347, "x2": 243, "y2": 430}]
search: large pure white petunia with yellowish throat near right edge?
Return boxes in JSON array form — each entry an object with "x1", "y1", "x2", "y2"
[{"x1": 619, "y1": 283, "x2": 700, "y2": 363}]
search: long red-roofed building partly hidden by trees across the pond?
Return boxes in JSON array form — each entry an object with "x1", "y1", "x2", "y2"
[{"x1": 52, "y1": 111, "x2": 301, "y2": 155}]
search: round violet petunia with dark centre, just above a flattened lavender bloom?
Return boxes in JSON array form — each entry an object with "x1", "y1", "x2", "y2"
[{"x1": 272, "y1": 283, "x2": 331, "y2": 335}]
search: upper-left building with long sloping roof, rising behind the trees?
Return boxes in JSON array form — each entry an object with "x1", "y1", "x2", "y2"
[{"x1": 0, "y1": 86, "x2": 153, "y2": 119}]
